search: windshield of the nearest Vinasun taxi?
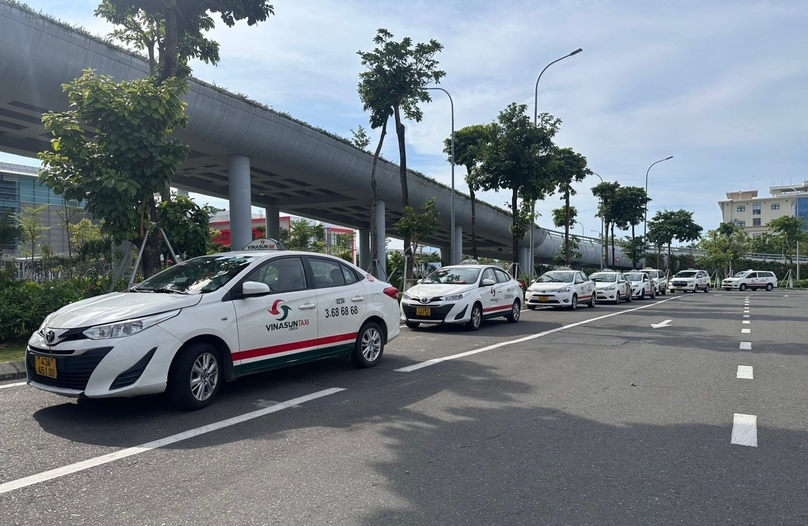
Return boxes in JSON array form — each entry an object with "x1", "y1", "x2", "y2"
[{"x1": 129, "y1": 254, "x2": 255, "y2": 294}]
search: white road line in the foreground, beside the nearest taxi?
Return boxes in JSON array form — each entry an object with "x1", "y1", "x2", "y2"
[{"x1": 0, "y1": 387, "x2": 345, "y2": 495}]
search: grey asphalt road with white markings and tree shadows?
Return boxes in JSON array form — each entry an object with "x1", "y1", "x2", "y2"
[{"x1": 0, "y1": 290, "x2": 808, "y2": 526}]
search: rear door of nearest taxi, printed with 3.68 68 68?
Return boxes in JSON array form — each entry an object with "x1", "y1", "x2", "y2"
[{"x1": 307, "y1": 256, "x2": 372, "y2": 357}]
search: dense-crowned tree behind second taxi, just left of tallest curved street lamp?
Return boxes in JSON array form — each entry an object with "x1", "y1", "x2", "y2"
[{"x1": 478, "y1": 103, "x2": 561, "y2": 276}]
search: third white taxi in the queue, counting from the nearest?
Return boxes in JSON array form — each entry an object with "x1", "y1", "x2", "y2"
[{"x1": 525, "y1": 270, "x2": 595, "y2": 310}]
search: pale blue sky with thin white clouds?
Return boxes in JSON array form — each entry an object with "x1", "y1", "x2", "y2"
[{"x1": 0, "y1": 0, "x2": 808, "y2": 248}]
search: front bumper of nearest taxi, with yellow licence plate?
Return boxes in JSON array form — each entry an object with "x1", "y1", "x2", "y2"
[{"x1": 25, "y1": 325, "x2": 181, "y2": 398}]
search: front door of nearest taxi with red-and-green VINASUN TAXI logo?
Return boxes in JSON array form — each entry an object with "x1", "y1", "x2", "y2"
[{"x1": 233, "y1": 256, "x2": 317, "y2": 375}]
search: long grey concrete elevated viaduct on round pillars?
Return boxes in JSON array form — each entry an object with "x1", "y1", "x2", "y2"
[{"x1": 0, "y1": 3, "x2": 620, "y2": 276}]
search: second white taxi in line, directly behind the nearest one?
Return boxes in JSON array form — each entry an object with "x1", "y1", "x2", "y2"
[{"x1": 401, "y1": 265, "x2": 522, "y2": 331}]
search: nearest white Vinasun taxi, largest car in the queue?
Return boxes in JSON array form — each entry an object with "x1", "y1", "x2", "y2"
[{"x1": 25, "y1": 251, "x2": 400, "y2": 409}]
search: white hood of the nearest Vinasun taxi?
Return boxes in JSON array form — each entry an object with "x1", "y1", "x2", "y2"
[{"x1": 43, "y1": 292, "x2": 202, "y2": 329}]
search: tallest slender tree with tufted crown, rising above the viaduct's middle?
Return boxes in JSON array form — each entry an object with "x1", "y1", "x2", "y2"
[{"x1": 358, "y1": 28, "x2": 446, "y2": 280}]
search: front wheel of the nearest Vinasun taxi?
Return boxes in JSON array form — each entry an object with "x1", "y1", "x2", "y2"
[{"x1": 168, "y1": 342, "x2": 222, "y2": 411}]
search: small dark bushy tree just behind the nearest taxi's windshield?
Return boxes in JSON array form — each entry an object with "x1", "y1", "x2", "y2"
[{"x1": 155, "y1": 195, "x2": 216, "y2": 263}]
